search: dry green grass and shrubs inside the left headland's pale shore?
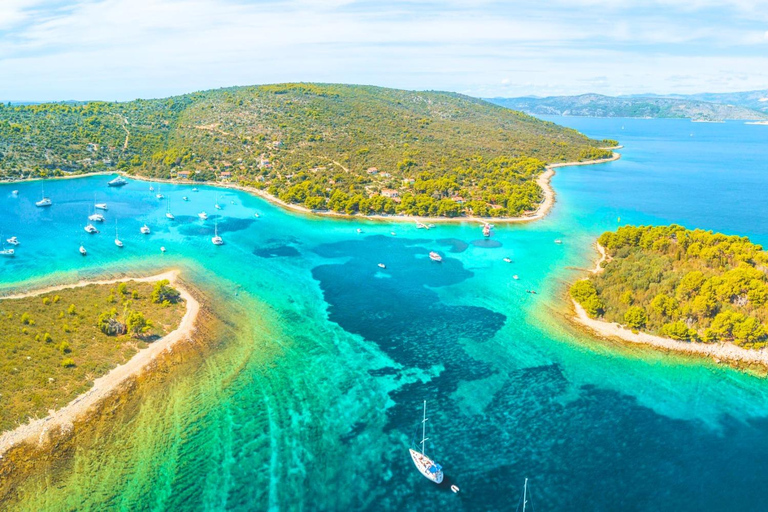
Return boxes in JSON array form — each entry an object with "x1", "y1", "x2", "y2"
[{"x1": 0, "y1": 281, "x2": 186, "y2": 431}]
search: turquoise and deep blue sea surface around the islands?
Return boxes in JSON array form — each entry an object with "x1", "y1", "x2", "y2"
[{"x1": 0, "y1": 118, "x2": 768, "y2": 512}]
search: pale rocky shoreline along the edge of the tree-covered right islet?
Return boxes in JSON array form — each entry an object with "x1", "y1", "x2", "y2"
[{"x1": 571, "y1": 244, "x2": 768, "y2": 370}]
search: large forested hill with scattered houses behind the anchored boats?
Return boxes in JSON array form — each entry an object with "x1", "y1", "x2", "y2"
[{"x1": 0, "y1": 84, "x2": 615, "y2": 216}]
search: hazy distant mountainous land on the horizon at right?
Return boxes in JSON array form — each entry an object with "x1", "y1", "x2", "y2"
[{"x1": 488, "y1": 94, "x2": 768, "y2": 122}]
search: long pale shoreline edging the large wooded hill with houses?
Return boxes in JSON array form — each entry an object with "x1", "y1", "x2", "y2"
[{"x1": 0, "y1": 151, "x2": 623, "y2": 224}]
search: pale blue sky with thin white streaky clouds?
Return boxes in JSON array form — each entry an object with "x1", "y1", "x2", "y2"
[{"x1": 0, "y1": 0, "x2": 768, "y2": 101}]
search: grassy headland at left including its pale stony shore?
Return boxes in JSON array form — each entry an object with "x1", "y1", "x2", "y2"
[{"x1": 0, "y1": 272, "x2": 198, "y2": 454}]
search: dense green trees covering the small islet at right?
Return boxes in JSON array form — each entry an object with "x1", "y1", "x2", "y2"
[{"x1": 571, "y1": 225, "x2": 768, "y2": 348}]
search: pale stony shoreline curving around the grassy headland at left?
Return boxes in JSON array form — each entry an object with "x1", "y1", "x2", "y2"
[{"x1": 0, "y1": 270, "x2": 200, "y2": 459}]
